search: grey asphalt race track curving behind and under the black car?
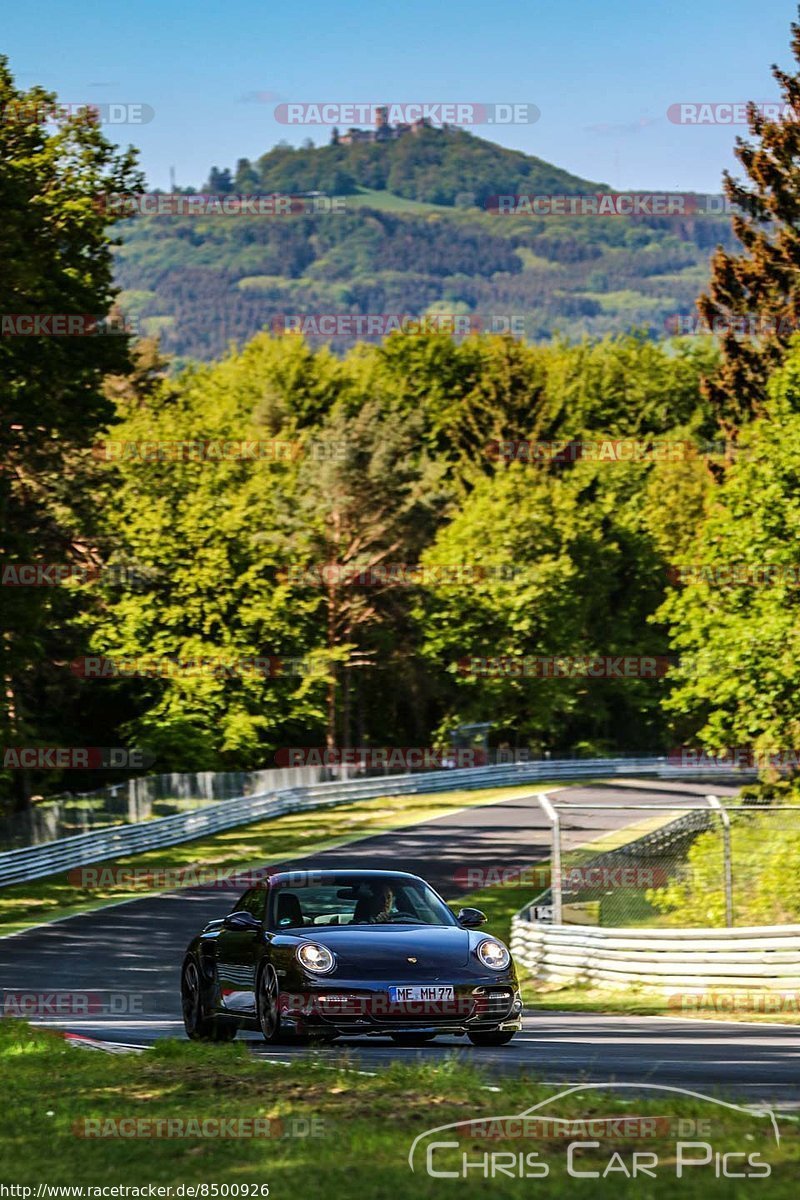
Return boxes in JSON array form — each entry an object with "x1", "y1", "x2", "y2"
[{"x1": 0, "y1": 781, "x2": 800, "y2": 1109}]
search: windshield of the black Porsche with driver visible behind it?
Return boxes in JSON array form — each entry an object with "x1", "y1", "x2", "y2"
[{"x1": 269, "y1": 875, "x2": 458, "y2": 930}]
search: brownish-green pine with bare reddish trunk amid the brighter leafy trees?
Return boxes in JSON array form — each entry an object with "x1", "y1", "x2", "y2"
[{"x1": 286, "y1": 398, "x2": 446, "y2": 746}]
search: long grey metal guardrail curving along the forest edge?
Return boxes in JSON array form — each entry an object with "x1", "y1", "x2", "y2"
[{"x1": 0, "y1": 757, "x2": 752, "y2": 887}]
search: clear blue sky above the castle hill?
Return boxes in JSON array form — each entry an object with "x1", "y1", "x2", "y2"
[{"x1": 0, "y1": 0, "x2": 796, "y2": 192}]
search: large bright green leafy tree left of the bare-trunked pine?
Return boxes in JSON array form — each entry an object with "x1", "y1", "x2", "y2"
[{"x1": 86, "y1": 335, "x2": 350, "y2": 770}]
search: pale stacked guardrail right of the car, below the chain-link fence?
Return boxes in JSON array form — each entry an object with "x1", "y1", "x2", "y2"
[{"x1": 511, "y1": 914, "x2": 800, "y2": 993}]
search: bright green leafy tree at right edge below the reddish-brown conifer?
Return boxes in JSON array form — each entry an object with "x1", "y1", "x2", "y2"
[{"x1": 660, "y1": 348, "x2": 800, "y2": 751}]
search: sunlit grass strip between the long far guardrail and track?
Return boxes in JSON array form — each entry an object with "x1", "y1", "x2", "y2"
[{"x1": 0, "y1": 782, "x2": 566, "y2": 936}]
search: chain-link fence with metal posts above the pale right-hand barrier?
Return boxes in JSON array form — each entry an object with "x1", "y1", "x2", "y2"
[{"x1": 530, "y1": 797, "x2": 800, "y2": 929}]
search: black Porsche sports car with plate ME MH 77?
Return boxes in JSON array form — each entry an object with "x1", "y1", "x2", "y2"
[{"x1": 181, "y1": 870, "x2": 522, "y2": 1046}]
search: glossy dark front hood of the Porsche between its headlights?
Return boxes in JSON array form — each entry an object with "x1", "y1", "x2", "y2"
[{"x1": 293, "y1": 925, "x2": 471, "y2": 973}]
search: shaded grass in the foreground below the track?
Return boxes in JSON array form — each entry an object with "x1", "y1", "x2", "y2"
[{"x1": 0, "y1": 1020, "x2": 800, "y2": 1200}]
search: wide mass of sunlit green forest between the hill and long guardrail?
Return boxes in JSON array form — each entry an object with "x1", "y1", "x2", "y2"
[{"x1": 51, "y1": 334, "x2": 708, "y2": 769}]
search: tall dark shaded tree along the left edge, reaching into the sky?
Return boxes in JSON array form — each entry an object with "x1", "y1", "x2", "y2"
[{"x1": 0, "y1": 58, "x2": 143, "y2": 805}]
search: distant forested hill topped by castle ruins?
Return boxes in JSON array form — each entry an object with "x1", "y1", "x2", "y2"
[{"x1": 116, "y1": 130, "x2": 733, "y2": 360}]
